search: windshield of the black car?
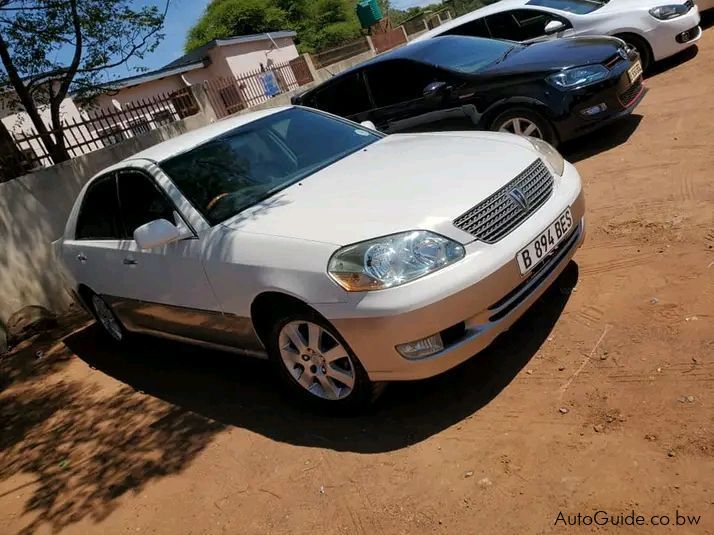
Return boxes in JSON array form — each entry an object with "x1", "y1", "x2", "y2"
[{"x1": 415, "y1": 35, "x2": 524, "y2": 74}]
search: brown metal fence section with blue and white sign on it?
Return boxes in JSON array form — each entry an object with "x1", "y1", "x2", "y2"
[{"x1": 203, "y1": 57, "x2": 312, "y2": 117}]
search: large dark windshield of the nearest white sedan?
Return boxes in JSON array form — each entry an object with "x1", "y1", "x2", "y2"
[{"x1": 160, "y1": 108, "x2": 381, "y2": 225}]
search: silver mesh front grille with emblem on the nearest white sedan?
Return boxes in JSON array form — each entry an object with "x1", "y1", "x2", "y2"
[{"x1": 454, "y1": 158, "x2": 553, "y2": 243}]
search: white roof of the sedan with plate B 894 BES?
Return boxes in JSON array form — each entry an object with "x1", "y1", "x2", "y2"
[{"x1": 129, "y1": 106, "x2": 292, "y2": 162}]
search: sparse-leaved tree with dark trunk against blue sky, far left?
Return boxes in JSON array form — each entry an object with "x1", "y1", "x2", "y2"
[{"x1": 0, "y1": 0, "x2": 170, "y2": 163}]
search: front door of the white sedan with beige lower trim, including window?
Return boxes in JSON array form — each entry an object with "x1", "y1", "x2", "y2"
[{"x1": 115, "y1": 168, "x2": 224, "y2": 343}]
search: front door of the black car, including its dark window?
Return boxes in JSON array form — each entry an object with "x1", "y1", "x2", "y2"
[{"x1": 365, "y1": 59, "x2": 472, "y2": 133}]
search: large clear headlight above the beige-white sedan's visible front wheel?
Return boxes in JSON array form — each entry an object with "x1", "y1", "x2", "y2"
[{"x1": 327, "y1": 230, "x2": 465, "y2": 292}]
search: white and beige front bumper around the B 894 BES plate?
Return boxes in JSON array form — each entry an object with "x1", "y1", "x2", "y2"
[{"x1": 317, "y1": 164, "x2": 585, "y2": 381}]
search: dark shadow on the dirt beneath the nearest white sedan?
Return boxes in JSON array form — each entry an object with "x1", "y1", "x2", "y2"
[{"x1": 65, "y1": 262, "x2": 578, "y2": 453}]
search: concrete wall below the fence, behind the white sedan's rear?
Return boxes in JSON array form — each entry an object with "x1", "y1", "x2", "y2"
[{"x1": 0, "y1": 113, "x2": 209, "y2": 323}]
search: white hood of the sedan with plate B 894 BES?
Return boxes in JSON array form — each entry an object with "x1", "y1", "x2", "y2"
[{"x1": 223, "y1": 132, "x2": 538, "y2": 245}]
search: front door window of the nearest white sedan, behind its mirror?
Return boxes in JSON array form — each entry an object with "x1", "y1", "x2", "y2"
[{"x1": 118, "y1": 171, "x2": 175, "y2": 240}]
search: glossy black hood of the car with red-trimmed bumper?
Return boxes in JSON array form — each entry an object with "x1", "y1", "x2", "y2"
[{"x1": 490, "y1": 36, "x2": 622, "y2": 74}]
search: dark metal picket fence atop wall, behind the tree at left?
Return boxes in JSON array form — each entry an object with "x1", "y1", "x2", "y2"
[{"x1": 5, "y1": 88, "x2": 199, "y2": 177}]
